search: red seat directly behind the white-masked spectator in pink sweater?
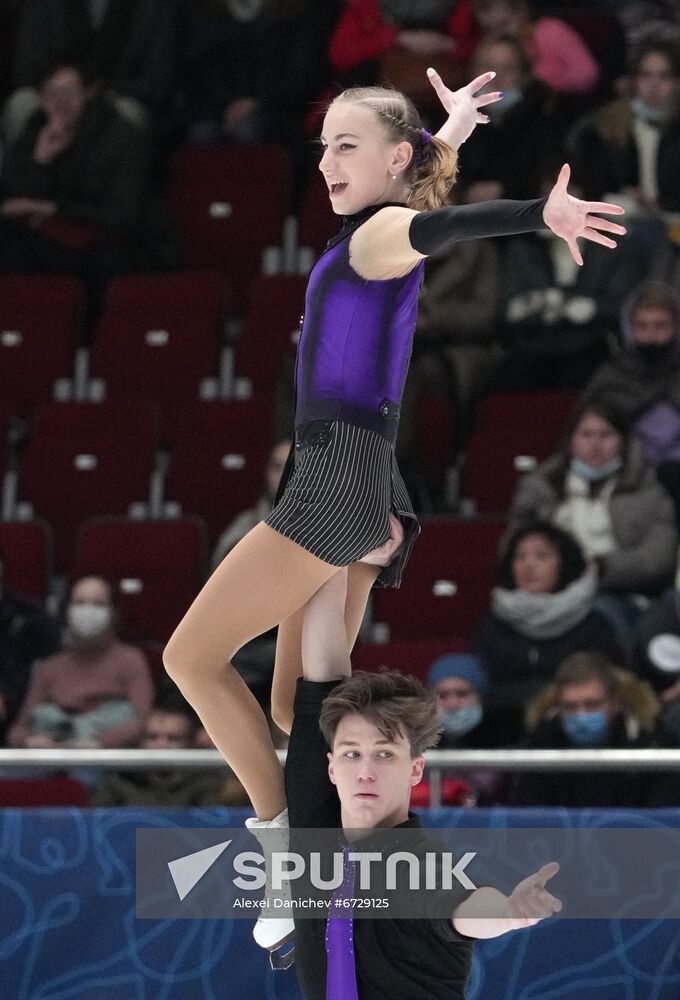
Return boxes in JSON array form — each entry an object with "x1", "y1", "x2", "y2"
[{"x1": 75, "y1": 518, "x2": 206, "y2": 642}]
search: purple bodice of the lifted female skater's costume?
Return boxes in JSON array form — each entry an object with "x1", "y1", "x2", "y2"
[{"x1": 295, "y1": 212, "x2": 424, "y2": 440}]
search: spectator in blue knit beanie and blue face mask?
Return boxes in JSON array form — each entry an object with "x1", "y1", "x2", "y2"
[{"x1": 412, "y1": 653, "x2": 510, "y2": 806}]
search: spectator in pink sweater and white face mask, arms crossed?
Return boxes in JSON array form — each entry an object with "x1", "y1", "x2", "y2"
[{"x1": 7, "y1": 575, "x2": 152, "y2": 748}]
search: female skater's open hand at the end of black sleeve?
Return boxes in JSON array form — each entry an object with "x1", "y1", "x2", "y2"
[{"x1": 543, "y1": 163, "x2": 626, "y2": 267}]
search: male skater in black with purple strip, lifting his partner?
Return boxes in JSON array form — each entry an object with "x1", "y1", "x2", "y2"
[{"x1": 286, "y1": 570, "x2": 562, "y2": 1000}]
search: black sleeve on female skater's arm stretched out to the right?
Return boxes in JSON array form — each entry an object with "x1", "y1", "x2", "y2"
[{"x1": 409, "y1": 198, "x2": 547, "y2": 254}]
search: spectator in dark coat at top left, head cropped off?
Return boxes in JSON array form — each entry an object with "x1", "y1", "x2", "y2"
[{"x1": 10, "y1": 0, "x2": 184, "y2": 135}]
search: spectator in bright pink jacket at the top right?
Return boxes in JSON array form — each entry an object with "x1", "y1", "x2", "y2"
[{"x1": 473, "y1": 0, "x2": 600, "y2": 94}]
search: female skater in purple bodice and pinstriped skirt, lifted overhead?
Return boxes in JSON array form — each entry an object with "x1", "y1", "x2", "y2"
[{"x1": 164, "y1": 64, "x2": 625, "y2": 947}]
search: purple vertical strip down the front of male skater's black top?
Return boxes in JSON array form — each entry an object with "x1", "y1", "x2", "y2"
[{"x1": 326, "y1": 845, "x2": 359, "y2": 1000}]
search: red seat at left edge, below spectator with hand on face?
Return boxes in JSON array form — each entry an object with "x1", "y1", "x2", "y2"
[{"x1": 0, "y1": 275, "x2": 84, "y2": 415}]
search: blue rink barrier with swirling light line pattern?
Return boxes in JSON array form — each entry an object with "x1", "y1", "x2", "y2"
[{"x1": 0, "y1": 808, "x2": 680, "y2": 1000}]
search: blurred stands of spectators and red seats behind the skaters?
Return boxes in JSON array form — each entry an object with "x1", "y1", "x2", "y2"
[{"x1": 0, "y1": 0, "x2": 680, "y2": 807}]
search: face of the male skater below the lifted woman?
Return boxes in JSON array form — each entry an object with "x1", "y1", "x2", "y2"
[{"x1": 328, "y1": 715, "x2": 425, "y2": 830}]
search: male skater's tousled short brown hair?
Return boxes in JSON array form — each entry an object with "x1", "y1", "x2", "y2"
[{"x1": 319, "y1": 670, "x2": 441, "y2": 758}]
